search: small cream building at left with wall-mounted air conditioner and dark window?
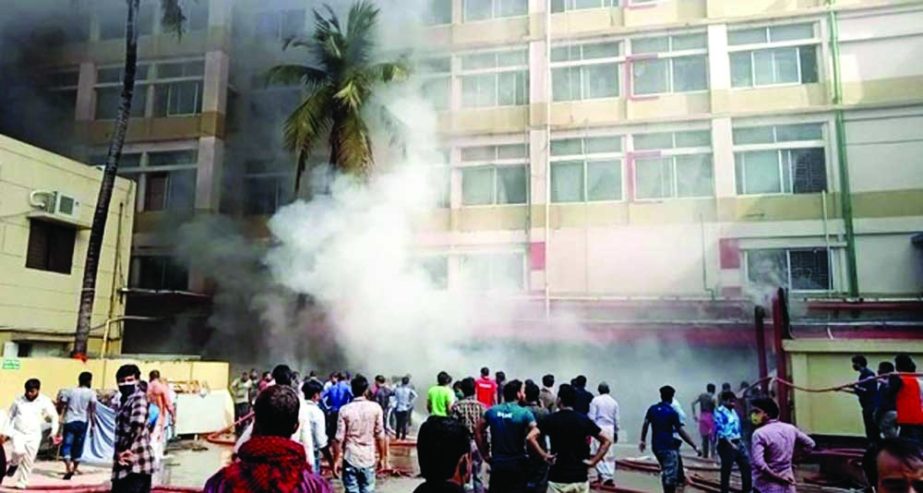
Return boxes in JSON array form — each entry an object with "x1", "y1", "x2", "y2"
[{"x1": 0, "y1": 135, "x2": 135, "y2": 356}]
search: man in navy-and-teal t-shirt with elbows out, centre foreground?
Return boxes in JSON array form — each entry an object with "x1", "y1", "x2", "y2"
[{"x1": 475, "y1": 380, "x2": 539, "y2": 493}]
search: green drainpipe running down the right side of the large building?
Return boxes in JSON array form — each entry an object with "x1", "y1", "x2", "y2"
[{"x1": 826, "y1": 0, "x2": 859, "y2": 298}]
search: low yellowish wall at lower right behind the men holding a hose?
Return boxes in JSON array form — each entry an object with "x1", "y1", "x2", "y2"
[{"x1": 784, "y1": 340, "x2": 923, "y2": 436}]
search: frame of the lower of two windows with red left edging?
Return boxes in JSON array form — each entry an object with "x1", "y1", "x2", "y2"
[{"x1": 631, "y1": 128, "x2": 716, "y2": 202}]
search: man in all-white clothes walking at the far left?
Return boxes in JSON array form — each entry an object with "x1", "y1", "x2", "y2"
[{"x1": 6, "y1": 378, "x2": 58, "y2": 489}]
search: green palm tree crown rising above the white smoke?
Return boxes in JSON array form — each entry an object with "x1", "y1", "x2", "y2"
[{"x1": 268, "y1": 0, "x2": 408, "y2": 193}]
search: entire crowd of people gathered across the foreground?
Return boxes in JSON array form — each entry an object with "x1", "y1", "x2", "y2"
[{"x1": 0, "y1": 354, "x2": 923, "y2": 493}]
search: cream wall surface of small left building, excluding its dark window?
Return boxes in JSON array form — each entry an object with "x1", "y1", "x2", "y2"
[{"x1": 0, "y1": 136, "x2": 134, "y2": 350}]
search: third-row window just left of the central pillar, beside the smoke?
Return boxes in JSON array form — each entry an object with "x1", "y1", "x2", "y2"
[{"x1": 461, "y1": 144, "x2": 529, "y2": 205}]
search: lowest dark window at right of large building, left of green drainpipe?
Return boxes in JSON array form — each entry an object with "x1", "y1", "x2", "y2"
[{"x1": 747, "y1": 248, "x2": 832, "y2": 291}]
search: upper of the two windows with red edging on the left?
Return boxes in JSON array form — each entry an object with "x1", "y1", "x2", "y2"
[{"x1": 631, "y1": 33, "x2": 708, "y2": 95}]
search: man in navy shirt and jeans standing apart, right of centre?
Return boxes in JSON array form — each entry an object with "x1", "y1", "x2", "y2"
[{"x1": 638, "y1": 385, "x2": 699, "y2": 493}]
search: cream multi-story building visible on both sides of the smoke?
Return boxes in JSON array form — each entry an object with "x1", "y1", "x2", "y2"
[{"x1": 1, "y1": 0, "x2": 923, "y2": 354}]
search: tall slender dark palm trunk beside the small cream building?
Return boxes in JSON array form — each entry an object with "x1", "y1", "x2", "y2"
[{"x1": 72, "y1": 0, "x2": 140, "y2": 359}]
